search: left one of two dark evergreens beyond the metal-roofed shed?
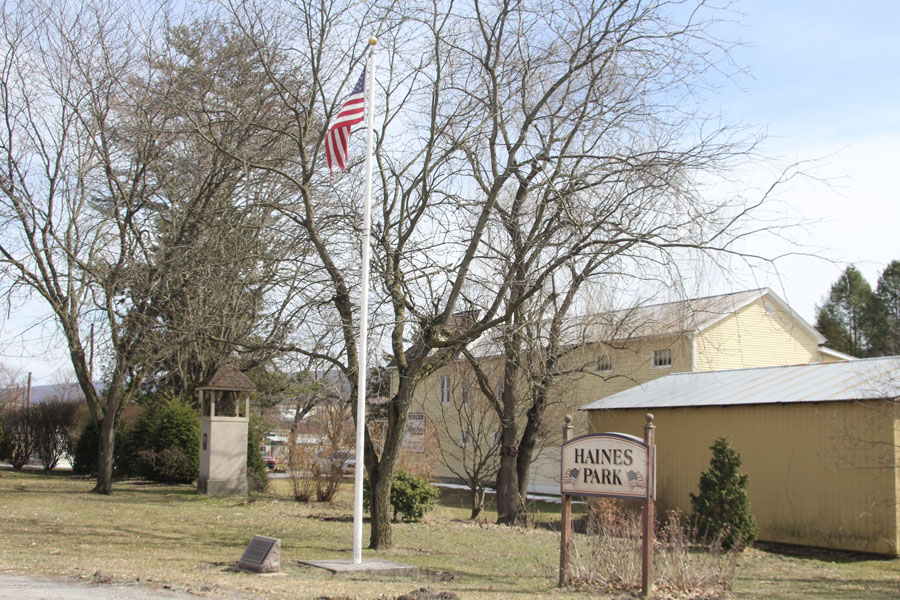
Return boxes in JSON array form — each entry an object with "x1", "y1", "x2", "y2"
[{"x1": 816, "y1": 265, "x2": 874, "y2": 357}]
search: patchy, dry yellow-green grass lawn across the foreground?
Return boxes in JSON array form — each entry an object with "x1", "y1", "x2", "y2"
[{"x1": 0, "y1": 471, "x2": 900, "y2": 600}]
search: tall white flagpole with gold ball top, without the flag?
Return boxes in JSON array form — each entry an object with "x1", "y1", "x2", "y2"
[{"x1": 353, "y1": 36, "x2": 378, "y2": 565}]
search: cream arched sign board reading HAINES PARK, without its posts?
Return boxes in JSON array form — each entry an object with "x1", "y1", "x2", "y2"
[{"x1": 560, "y1": 433, "x2": 652, "y2": 500}]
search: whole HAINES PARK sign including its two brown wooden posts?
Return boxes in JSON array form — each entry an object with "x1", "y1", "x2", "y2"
[{"x1": 559, "y1": 413, "x2": 656, "y2": 597}]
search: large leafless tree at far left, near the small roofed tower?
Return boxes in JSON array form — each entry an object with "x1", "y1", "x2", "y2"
[{"x1": 0, "y1": 0, "x2": 310, "y2": 493}]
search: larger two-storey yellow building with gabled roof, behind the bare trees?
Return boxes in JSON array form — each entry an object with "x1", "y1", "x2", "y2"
[{"x1": 412, "y1": 288, "x2": 851, "y2": 494}]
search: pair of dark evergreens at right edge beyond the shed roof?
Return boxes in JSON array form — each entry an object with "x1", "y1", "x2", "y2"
[{"x1": 816, "y1": 260, "x2": 900, "y2": 358}]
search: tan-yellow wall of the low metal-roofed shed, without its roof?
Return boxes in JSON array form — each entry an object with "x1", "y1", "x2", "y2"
[{"x1": 588, "y1": 401, "x2": 900, "y2": 554}]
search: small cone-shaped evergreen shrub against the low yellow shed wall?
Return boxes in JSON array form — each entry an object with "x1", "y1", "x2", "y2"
[{"x1": 688, "y1": 437, "x2": 758, "y2": 549}]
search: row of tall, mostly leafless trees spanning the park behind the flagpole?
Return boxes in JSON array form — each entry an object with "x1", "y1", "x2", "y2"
[{"x1": 0, "y1": 0, "x2": 788, "y2": 548}]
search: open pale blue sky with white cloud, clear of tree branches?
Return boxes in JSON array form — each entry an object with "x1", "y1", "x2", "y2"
[{"x1": 0, "y1": 0, "x2": 900, "y2": 384}]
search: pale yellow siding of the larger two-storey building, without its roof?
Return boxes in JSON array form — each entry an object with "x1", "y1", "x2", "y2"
[{"x1": 412, "y1": 295, "x2": 836, "y2": 493}]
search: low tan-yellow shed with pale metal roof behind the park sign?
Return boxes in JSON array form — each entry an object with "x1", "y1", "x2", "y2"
[{"x1": 583, "y1": 357, "x2": 900, "y2": 555}]
